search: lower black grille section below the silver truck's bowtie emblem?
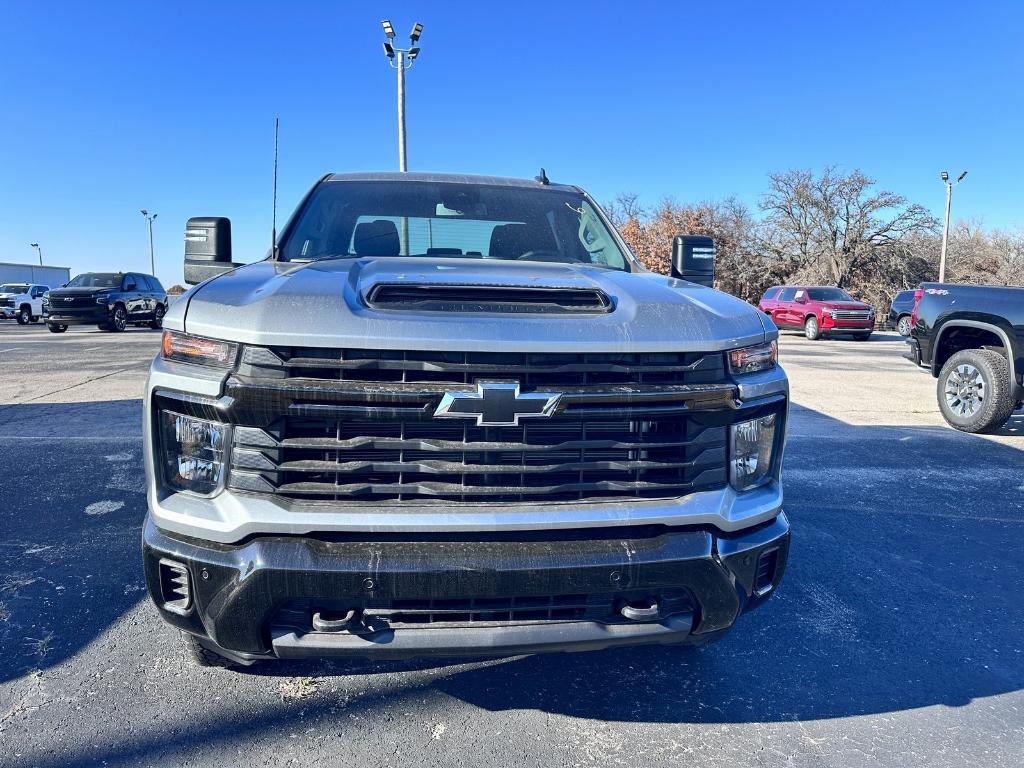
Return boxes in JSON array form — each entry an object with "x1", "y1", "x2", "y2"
[{"x1": 230, "y1": 418, "x2": 726, "y2": 503}]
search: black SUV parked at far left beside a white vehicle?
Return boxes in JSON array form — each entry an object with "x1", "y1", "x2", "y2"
[{"x1": 44, "y1": 272, "x2": 167, "y2": 334}]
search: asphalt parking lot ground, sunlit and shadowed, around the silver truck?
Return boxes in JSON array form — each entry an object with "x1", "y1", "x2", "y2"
[{"x1": 0, "y1": 323, "x2": 1024, "y2": 768}]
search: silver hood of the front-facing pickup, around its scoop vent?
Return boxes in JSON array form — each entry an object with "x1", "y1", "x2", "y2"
[{"x1": 174, "y1": 257, "x2": 777, "y2": 352}]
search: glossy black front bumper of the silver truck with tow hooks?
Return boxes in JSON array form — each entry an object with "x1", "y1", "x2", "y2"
[{"x1": 142, "y1": 512, "x2": 790, "y2": 662}]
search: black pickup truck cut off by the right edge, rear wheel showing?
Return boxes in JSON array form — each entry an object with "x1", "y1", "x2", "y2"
[{"x1": 910, "y1": 283, "x2": 1024, "y2": 432}]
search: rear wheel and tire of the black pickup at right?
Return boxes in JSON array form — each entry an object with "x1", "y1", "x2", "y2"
[{"x1": 937, "y1": 349, "x2": 1017, "y2": 433}]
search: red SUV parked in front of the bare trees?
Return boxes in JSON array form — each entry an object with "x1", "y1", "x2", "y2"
[{"x1": 758, "y1": 286, "x2": 874, "y2": 341}]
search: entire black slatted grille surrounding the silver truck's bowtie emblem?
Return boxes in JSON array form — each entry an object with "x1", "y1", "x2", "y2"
[{"x1": 226, "y1": 347, "x2": 734, "y2": 505}]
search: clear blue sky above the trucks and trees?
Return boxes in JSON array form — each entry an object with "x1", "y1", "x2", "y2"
[{"x1": 0, "y1": 0, "x2": 1024, "y2": 285}]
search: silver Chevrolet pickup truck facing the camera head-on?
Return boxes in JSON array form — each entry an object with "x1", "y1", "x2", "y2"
[{"x1": 143, "y1": 173, "x2": 790, "y2": 666}]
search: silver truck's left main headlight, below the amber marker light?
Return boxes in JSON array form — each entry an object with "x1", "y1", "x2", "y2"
[{"x1": 160, "y1": 411, "x2": 227, "y2": 496}]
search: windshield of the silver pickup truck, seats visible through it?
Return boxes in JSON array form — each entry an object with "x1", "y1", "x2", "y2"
[{"x1": 281, "y1": 181, "x2": 629, "y2": 269}]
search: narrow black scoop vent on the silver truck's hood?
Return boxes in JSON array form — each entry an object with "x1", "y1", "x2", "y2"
[{"x1": 365, "y1": 283, "x2": 612, "y2": 314}]
